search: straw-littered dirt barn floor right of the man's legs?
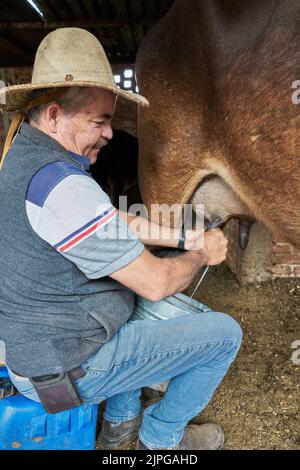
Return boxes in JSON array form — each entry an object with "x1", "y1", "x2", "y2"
[{"x1": 97, "y1": 266, "x2": 300, "y2": 450}]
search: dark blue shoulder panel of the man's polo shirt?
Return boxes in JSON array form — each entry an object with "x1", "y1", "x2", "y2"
[{"x1": 26, "y1": 161, "x2": 95, "y2": 207}]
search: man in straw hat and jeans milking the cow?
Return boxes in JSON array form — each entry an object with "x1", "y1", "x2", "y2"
[{"x1": 0, "y1": 28, "x2": 241, "y2": 449}]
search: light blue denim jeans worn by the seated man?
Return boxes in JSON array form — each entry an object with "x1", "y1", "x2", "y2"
[{"x1": 10, "y1": 294, "x2": 242, "y2": 449}]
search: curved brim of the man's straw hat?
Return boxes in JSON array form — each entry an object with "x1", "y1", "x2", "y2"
[{"x1": 0, "y1": 80, "x2": 149, "y2": 112}]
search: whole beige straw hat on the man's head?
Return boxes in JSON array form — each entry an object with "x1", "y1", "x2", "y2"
[{"x1": 0, "y1": 28, "x2": 149, "y2": 112}]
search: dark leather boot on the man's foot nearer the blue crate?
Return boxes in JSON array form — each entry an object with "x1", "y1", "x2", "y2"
[{"x1": 97, "y1": 413, "x2": 142, "y2": 450}]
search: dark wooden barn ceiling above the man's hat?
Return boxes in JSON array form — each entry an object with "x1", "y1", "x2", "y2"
[{"x1": 0, "y1": 0, "x2": 174, "y2": 67}]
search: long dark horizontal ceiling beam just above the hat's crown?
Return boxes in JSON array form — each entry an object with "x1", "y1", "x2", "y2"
[{"x1": 0, "y1": 18, "x2": 160, "y2": 31}]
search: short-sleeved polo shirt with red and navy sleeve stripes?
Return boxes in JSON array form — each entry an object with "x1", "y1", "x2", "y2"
[{"x1": 26, "y1": 152, "x2": 144, "y2": 279}]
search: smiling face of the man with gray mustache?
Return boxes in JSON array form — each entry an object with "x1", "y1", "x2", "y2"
[{"x1": 57, "y1": 89, "x2": 116, "y2": 164}]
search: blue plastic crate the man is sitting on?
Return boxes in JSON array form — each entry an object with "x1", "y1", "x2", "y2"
[{"x1": 0, "y1": 367, "x2": 98, "y2": 450}]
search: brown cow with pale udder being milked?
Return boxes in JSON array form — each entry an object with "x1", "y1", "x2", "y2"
[{"x1": 136, "y1": 0, "x2": 300, "y2": 249}]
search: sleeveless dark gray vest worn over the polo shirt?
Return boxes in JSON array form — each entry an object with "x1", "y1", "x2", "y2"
[{"x1": 0, "y1": 124, "x2": 134, "y2": 377}]
